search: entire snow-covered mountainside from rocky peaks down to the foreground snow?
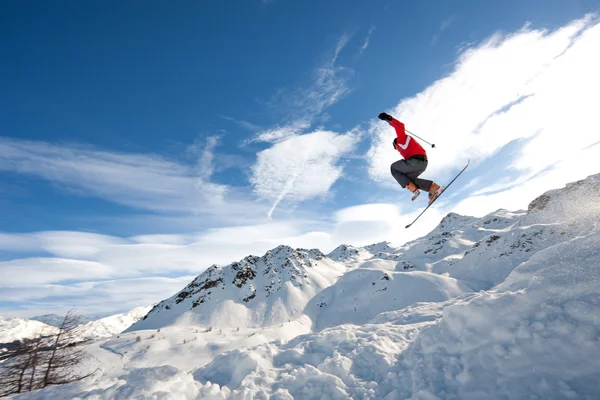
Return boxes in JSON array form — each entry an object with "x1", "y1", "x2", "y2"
[{"x1": 11, "y1": 174, "x2": 600, "y2": 400}]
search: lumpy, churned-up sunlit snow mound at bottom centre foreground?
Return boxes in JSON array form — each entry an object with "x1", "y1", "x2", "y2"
[{"x1": 194, "y1": 324, "x2": 426, "y2": 399}]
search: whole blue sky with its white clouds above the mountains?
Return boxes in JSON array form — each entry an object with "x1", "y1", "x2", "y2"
[{"x1": 0, "y1": 0, "x2": 600, "y2": 315}]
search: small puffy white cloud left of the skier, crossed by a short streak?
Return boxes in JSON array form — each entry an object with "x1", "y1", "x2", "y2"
[{"x1": 250, "y1": 131, "x2": 356, "y2": 216}]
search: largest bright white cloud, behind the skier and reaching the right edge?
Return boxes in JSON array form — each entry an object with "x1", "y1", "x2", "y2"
[{"x1": 368, "y1": 17, "x2": 600, "y2": 222}]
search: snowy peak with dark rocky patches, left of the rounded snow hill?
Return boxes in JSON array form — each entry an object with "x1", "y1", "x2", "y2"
[{"x1": 127, "y1": 246, "x2": 347, "y2": 332}]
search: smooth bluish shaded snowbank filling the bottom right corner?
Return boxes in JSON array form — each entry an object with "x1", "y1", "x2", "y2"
[{"x1": 389, "y1": 233, "x2": 600, "y2": 399}]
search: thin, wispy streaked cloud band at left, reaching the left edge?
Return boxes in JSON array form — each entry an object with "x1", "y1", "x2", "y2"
[{"x1": 0, "y1": 137, "x2": 227, "y2": 212}]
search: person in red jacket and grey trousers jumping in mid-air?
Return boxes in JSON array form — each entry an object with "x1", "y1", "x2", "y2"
[{"x1": 379, "y1": 113, "x2": 442, "y2": 204}]
